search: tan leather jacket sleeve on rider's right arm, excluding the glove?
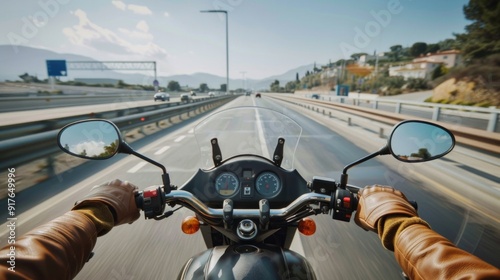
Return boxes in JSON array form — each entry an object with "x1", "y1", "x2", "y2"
[{"x1": 379, "y1": 217, "x2": 500, "y2": 279}]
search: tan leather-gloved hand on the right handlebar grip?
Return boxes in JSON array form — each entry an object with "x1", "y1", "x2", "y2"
[{"x1": 354, "y1": 185, "x2": 418, "y2": 232}]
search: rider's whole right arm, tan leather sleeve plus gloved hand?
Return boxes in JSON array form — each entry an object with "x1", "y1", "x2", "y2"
[{"x1": 355, "y1": 186, "x2": 500, "y2": 279}]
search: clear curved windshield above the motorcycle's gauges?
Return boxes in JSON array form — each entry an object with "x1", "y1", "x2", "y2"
[{"x1": 194, "y1": 107, "x2": 302, "y2": 169}]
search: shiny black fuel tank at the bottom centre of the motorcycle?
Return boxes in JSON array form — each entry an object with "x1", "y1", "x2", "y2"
[{"x1": 177, "y1": 244, "x2": 316, "y2": 280}]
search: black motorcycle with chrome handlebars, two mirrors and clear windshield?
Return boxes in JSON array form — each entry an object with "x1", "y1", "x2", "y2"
[{"x1": 58, "y1": 107, "x2": 455, "y2": 279}]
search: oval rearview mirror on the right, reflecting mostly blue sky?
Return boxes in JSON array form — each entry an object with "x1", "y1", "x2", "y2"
[{"x1": 388, "y1": 120, "x2": 455, "y2": 162}]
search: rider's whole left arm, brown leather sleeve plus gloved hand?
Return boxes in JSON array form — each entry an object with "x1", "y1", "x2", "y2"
[{"x1": 0, "y1": 180, "x2": 139, "y2": 279}]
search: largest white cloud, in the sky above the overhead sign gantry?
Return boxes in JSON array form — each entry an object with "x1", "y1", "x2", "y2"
[{"x1": 63, "y1": 10, "x2": 167, "y2": 59}]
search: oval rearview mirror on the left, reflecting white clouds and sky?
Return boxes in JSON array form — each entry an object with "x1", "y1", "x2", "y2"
[{"x1": 57, "y1": 120, "x2": 122, "y2": 159}]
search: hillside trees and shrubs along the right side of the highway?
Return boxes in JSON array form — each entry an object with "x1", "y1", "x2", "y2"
[{"x1": 270, "y1": 0, "x2": 500, "y2": 107}]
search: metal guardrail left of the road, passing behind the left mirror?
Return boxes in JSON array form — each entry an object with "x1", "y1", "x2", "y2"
[{"x1": 0, "y1": 95, "x2": 236, "y2": 173}]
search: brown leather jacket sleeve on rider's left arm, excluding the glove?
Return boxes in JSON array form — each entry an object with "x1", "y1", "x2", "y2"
[{"x1": 0, "y1": 205, "x2": 113, "y2": 280}]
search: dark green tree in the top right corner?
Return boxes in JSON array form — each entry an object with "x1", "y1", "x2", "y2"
[{"x1": 455, "y1": 0, "x2": 500, "y2": 59}]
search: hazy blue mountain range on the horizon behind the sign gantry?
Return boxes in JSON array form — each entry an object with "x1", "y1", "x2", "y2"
[{"x1": 0, "y1": 45, "x2": 314, "y2": 90}]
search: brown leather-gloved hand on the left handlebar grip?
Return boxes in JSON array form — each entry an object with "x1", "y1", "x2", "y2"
[{"x1": 72, "y1": 180, "x2": 140, "y2": 226}]
